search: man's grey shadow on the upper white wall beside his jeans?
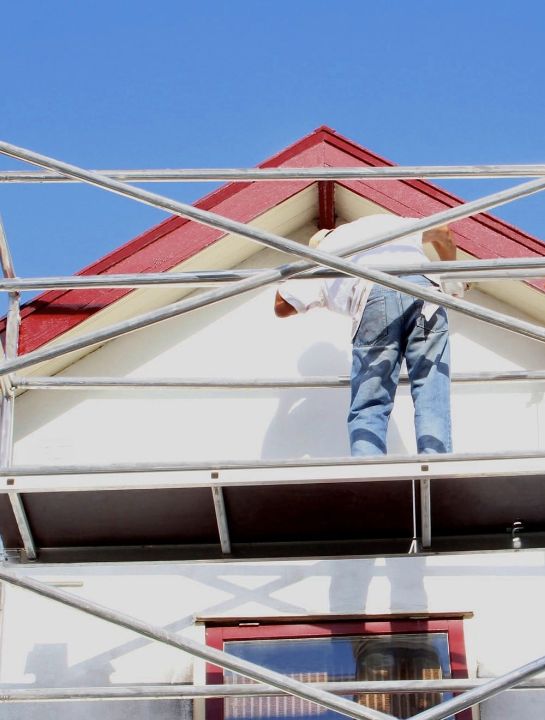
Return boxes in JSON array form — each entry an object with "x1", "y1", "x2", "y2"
[{"x1": 261, "y1": 342, "x2": 404, "y2": 460}]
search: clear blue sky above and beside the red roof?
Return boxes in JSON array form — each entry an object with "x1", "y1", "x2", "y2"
[{"x1": 0, "y1": 0, "x2": 545, "y2": 306}]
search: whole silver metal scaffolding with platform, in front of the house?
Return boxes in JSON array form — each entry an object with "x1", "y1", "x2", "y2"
[{"x1": 0, "y1": 142, "x2": 545, "y2": 720}]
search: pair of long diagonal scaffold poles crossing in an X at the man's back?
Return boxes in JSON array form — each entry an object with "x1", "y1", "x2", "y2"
[{"x1": 0, "y1": 142, "x2": 545, "y2": 375}]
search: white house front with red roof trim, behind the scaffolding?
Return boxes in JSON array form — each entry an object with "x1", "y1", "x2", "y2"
[{"x1": 0, "y1": 128, "x2": 545, "y2": 720}]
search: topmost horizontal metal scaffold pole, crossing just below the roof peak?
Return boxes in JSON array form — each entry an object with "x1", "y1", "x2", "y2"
[{"x1": 0, "y1": 164, "x2": 545, "y2": 183}]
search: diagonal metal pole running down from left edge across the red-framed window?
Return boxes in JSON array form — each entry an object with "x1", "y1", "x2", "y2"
[{"x1": 0, "y1": 568, "x2": 395, "y2": 720}]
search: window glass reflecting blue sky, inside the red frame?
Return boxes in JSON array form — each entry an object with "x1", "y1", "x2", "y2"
[{"x1": 224, "y1": 632, "x2": 451, "y2": 720}]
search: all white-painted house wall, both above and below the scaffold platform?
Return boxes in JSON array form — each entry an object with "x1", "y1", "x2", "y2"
[{"x1": 1, "y1": 262, "x2": 545, "y2": 720}]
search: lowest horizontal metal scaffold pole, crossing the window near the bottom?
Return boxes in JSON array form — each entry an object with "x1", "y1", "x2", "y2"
[{"x1": 0, "y1": 678, "x2": 545, "y2": 703}]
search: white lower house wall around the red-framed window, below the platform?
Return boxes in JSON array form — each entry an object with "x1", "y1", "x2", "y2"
[{"x1": 1, "y1": 551, "x2": 545, "y2": 720}]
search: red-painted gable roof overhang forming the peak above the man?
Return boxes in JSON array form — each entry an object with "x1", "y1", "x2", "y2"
[{"x1": 4, "y1": 127, "x2": 545, "y2": 353}]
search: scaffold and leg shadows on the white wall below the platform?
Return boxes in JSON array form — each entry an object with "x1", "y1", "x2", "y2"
[{"x1": 3, "y1": 557, "x2": 427, "y2": 720}]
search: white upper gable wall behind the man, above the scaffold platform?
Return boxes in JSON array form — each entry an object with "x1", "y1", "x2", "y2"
[{"x1": 10, "y1": 282, "x2": 545, "y2": 464}]
